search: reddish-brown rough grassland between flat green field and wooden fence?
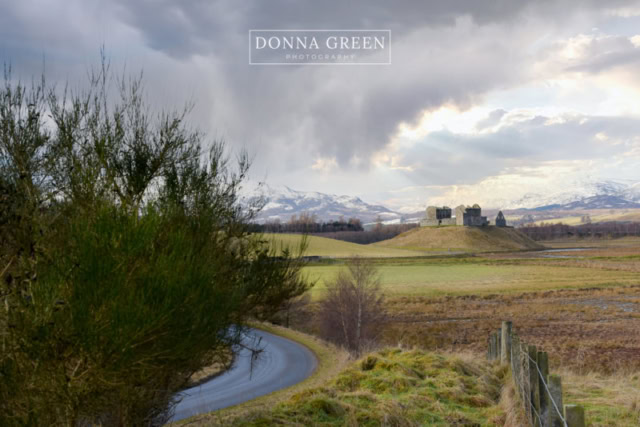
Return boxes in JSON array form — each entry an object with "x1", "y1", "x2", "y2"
[{"x1": 385, "y1": 286, "x2": 640, "y2": 372}]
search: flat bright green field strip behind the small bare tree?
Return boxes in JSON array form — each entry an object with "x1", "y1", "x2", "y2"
[{"x1": 304, "y1": 262, "x2": 640, "y2": 297}]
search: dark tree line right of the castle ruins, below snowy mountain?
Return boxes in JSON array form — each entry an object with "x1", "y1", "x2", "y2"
[{"x1": 518, "y1": 221, "x2": 640, "y2": 240}]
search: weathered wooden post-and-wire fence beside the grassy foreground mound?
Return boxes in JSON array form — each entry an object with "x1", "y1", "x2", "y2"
[{"x1": 487, "y1": 322, "x2": 585, "y2": 427}]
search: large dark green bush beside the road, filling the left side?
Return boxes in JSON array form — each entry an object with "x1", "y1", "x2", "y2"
[{"x1": 0, "y1": 65, "x2": 308, "y2": 425}]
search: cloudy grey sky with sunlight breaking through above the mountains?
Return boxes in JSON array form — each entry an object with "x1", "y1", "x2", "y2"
[{"x1": 0, "y1": 0, "x2": 640, "y2": 211}]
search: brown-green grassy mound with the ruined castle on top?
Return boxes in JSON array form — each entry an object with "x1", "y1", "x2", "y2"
[{"x1": 375, "y1": 226, "x2": 542, "y2": 252}]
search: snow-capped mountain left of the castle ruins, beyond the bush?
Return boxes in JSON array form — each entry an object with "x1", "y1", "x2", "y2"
[{"x1": 251, "y1": 186, "x2": 402, "y2": 223}]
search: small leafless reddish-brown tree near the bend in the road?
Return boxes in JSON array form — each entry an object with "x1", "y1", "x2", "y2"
[{"x1": 318, "y1": 258, "x2": 387, "y2": 356}]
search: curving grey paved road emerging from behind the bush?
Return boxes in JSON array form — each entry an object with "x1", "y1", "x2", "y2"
[{"x1": 172, "y1": 329, "x2": 318, "y2": 421}]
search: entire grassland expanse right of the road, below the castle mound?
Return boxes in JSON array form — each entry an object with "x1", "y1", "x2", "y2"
[{"x1": 185, "y1": 235, "x2": 640, "y2": 426}]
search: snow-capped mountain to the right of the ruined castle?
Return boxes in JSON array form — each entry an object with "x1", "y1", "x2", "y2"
[{"x1": 505, "y1": 180, "x2": 640, "y2": 210}]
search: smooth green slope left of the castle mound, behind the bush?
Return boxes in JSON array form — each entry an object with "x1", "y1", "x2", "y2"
[{"x1": 265, "y1": 234, "x2": 425, "y2": 258}]
